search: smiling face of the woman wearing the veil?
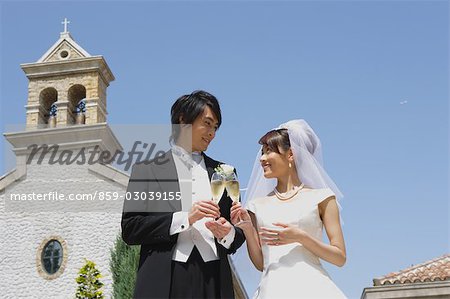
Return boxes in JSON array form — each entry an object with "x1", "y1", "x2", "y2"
[{"x1": 259, "y1": 145, "x2": 289, "y2": 179}]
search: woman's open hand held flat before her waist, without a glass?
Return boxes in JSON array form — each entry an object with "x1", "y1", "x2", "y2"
[{"x1": 259, "y1": 222, "x2": 306, "y2": 246}]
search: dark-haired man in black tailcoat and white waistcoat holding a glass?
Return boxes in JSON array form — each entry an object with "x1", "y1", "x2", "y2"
[{"x1": 122, "y1": 90, "x2": 245, "y2": 298}]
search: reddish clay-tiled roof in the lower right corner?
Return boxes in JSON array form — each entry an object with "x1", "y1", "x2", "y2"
[{"x1": 373, "y1": 254, "x2": 450, "y2": 286}]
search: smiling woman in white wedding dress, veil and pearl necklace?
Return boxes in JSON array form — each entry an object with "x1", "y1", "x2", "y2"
[{"x1": 231, "y1": 120, "x2": 346, "y2": 299}]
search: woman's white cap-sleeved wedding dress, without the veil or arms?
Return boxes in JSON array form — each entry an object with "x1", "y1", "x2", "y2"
[{"x1": 247, "y1": 188, "x2": 346, "y2": 299}]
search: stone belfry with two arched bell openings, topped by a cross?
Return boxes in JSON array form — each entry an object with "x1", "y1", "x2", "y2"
[{"x1": 21, "y1": 19, "x2": 114, "y2": 130}]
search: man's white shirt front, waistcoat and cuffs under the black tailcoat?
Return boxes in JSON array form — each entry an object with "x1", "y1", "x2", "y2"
[{"x1": 169, "y1": 146, "x2": 235, "y2": 262}]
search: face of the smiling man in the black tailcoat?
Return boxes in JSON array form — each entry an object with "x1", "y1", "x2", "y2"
[{"x1": 192, "y1": 105, "x2": 219, "y2": 152}]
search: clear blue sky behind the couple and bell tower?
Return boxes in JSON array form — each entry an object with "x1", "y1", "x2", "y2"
[{"x1": 0, "y1": 1, "x2": 449, "y2": 298}]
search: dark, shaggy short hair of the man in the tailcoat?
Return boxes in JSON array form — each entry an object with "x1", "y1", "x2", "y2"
[{"x1": 170, "y1": 90, "x2": 222, "y2": 141}]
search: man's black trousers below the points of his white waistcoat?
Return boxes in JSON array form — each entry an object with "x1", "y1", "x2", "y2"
[{"x1": 170, "y1": 246, "x2": 220, "y2": 299}]
